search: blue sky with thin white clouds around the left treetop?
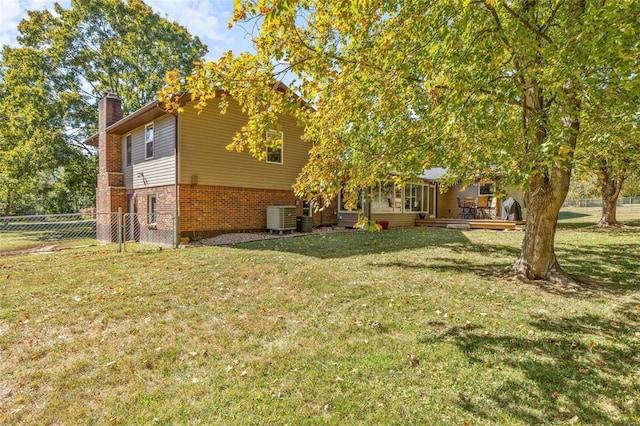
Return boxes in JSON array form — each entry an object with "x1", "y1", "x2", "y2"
[{"x1": 0, "y1": 0, "x2": 253, "y2": 60}]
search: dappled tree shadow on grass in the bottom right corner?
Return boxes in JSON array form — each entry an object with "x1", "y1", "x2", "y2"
[{"x1": 419, "y1": 301, "x2": 640, "y2": 424}]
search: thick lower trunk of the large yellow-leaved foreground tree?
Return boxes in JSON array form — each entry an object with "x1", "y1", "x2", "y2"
[{"x1": 511, "y1": 167, "x2": 571, "y2": 283}]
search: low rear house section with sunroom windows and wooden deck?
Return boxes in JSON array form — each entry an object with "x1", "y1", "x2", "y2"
[{"x1": 338, "y1": 168, "x2": 526, "y2": 227}]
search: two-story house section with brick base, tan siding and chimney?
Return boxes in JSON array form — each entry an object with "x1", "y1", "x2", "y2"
[{"x1": 85, "y1": 94, "x2": 337, "y2": 241}]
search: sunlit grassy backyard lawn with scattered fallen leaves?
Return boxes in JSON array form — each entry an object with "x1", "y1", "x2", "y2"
[{"x1": 0, "y1": 228, "x2": 640, "y2": 425}]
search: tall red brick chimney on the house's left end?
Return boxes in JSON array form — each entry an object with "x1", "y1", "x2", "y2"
[{"x1": 96, "y1": 93, "x2": 127, "y2": 241}]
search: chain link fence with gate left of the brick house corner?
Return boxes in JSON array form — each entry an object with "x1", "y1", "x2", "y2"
[{"x1": 0, "y1": 212, "x2": 178, "y2": 254}]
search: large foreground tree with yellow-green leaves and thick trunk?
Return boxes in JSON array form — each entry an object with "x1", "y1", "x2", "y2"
[{"x1": 163, "y1": 0, "x2": 640, "y2": 281}]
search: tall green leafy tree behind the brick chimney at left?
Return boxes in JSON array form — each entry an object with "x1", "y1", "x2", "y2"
[{"x1": 0, "y1": 0, "x2": 207, "y2": 214}]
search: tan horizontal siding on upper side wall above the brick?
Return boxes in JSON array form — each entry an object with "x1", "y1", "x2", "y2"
[{"x1": 178, "y1": 100, "x2": 311, "y2": 190}]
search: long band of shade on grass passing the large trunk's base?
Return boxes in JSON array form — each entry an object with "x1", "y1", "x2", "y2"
[{"x1": 234, "y1": 228, "x2": 640, "y2": 297}]
